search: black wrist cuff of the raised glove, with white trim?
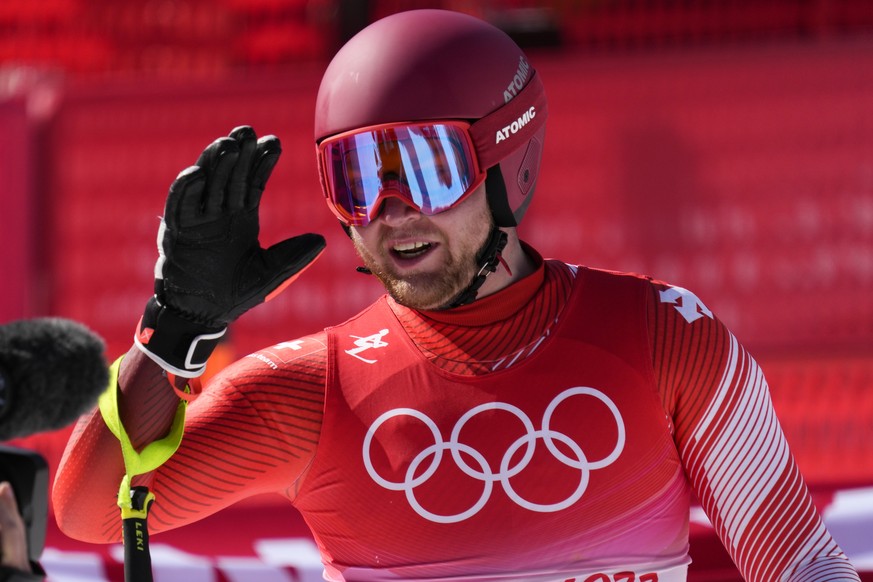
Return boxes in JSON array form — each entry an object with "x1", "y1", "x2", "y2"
[{"x1": 133, "y1": 297, "x2": 227, "y2": 378}]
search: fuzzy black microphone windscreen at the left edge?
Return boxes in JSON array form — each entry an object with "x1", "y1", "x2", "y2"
[{"x1": 0, "y1": 317, "x2": 109, "y2": 441}]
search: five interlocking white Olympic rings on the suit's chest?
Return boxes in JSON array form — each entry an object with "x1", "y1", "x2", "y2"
[{"x1": 363, "y1": 387, "x2": 625, "y2": 523}]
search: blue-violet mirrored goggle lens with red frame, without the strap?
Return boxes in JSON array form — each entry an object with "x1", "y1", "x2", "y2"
[{"x1": 321, "y1": 123, "x2": 481, "y2": 226}]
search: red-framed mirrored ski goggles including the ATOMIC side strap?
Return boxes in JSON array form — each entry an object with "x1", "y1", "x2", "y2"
[{"x1": 317, "y1": 70, "x2": 546, "y2": 226}]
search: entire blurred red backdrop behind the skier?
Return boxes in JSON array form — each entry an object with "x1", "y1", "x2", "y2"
[{"x1": 0, "y1": 0, "x2": 873, "y2": 580}]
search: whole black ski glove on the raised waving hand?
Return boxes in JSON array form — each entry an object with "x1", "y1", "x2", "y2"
[{"x1": 135, "y1": 126, "x2": 325, "y2": 378}]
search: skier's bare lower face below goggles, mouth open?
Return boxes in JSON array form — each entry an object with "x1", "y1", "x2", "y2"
[{"x1": 351, "y1": 185, "x2": 492, "y2": 309}]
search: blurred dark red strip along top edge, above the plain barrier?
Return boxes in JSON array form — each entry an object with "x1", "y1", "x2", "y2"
[{"x1": 0, "y1": 0, "x2": 873, "y2": 78}]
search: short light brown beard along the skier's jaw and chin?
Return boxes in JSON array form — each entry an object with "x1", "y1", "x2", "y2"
[{"x1": 352, "y1": 211, "x2": 494, "y2": 310}]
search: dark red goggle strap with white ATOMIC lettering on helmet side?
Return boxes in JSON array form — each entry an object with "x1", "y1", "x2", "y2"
[{"x1": 469, "y1": 72, "x2": 548, "y2": 171}]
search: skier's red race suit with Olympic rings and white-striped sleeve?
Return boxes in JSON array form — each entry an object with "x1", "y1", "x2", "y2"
[{"x1": 54, "y1": 247, "x2": 858, "y2": 582}]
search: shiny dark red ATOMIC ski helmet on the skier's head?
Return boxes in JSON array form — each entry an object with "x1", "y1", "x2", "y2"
[{"x1": 315, "y1": 10, "x2": 547, "y2": 227}]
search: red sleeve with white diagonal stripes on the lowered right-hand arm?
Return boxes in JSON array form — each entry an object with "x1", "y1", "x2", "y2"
[{"x1": 649, "y1": 284, "x2": 859, "y2": 582}]
